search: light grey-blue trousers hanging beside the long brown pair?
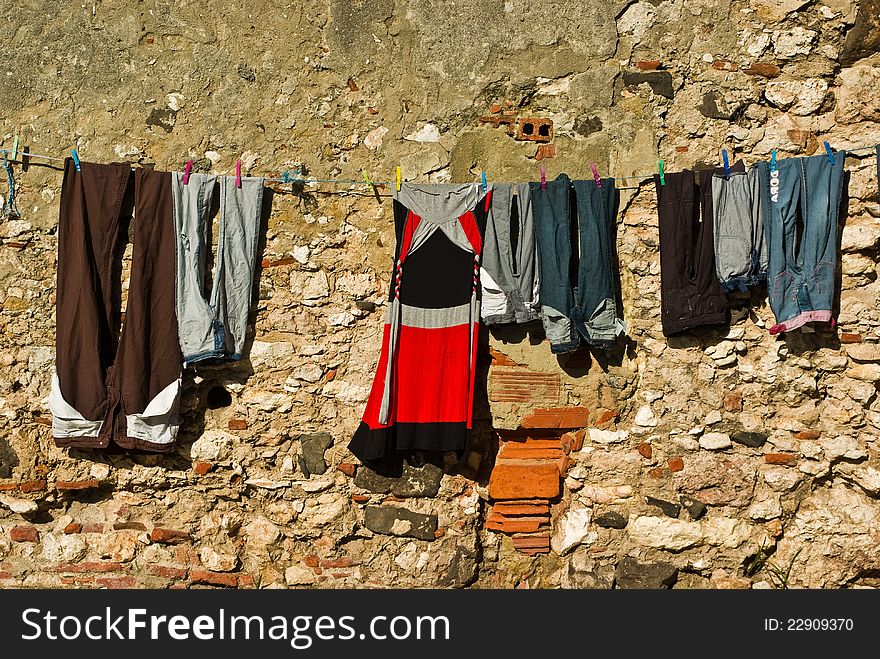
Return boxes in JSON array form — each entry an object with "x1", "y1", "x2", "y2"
[{"x1": 172, "y1": 172, "x2": 263, "y2": 364}]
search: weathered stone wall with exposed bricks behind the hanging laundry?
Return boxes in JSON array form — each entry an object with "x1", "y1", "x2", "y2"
[{"x1": 0, "y1": 0, "x2": 880, "y2": 588}]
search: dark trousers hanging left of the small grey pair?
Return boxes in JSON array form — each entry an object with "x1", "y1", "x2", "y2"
[{"x1": 654, "y1": 161, "x2": 745, "y2": 336}]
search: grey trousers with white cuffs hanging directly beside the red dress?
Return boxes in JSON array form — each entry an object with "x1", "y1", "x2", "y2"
[{"x1": 480, "y1": 183, "x2": 540, "y2": 325}]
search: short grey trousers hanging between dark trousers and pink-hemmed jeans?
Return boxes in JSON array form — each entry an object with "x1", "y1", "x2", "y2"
[{"x1": 712, "y1": 167, "x2": 767, "y2": 293}]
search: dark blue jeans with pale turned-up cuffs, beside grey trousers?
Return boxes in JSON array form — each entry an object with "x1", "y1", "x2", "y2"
[{"x1": 529, "y1": 174, "x2": 626, "y2": 353}]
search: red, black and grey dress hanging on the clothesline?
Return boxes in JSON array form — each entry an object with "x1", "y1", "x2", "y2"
[{"x1": 348, "y1": 183, "x2": 491, "y2": 461}]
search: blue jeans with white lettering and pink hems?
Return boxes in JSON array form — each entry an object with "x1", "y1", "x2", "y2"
[{"x1": 758, "y1": 151, "x2": 846, "y2": 334}]
